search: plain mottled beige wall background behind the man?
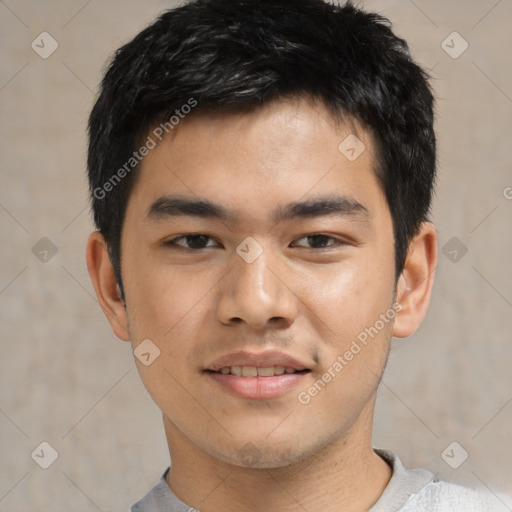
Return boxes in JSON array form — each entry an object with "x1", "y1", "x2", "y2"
[{"x1": 0, "y1": 0, "x2": 512, "y2": 512}]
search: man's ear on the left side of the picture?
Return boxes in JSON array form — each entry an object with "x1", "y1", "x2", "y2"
[{"x1": 86, "y1": 231, "x2": 130, "y2": 341}]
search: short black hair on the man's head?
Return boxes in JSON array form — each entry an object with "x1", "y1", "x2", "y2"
[{"x1": 88, "y1": 0, "x2": 436, "y2": 297}]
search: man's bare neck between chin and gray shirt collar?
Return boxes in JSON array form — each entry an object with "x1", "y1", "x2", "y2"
[{"x1": 164, "y1": 404, "x2": 391, "y2": 512}]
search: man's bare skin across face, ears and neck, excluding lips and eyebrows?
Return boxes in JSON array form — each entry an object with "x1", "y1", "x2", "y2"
[{"x1": 87, "y1": 98, "x2": 437, "y2": 512}]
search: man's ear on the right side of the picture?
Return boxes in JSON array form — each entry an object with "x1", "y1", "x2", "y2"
[{"x1": 393, "y1": 222, "x2": 437, "y2": 338}]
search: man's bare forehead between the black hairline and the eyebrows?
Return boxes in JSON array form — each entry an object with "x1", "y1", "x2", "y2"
[{"x1": 130, "y1": 98, "x2": 385, "y2": 224}]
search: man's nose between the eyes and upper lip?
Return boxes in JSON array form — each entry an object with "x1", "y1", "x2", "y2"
[{"x1": 217, "y1": 250, "x2": 298, "y2": 330}]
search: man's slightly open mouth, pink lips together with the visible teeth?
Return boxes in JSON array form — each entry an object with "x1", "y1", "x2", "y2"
[{"x1": 204, "y1": 351, "x2": 311, "y2": 400}]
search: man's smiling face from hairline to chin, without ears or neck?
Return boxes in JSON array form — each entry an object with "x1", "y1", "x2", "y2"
[{"x1": 122, "y1": 96, "x2": 395, "y2": 467}]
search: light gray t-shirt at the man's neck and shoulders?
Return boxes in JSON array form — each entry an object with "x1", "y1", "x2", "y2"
[{"x1": 131, "y1": 449, "x2": 510, "y2": 512}]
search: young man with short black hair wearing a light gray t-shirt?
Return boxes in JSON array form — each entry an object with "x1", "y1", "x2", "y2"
[{"x1": 87, "y1": 0, "x2": 502, "y2": 512}]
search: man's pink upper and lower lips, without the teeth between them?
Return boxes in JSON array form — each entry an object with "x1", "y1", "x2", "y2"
[{"x1": 205, "y1": 350, "x2": 309, "y2": 400}]
